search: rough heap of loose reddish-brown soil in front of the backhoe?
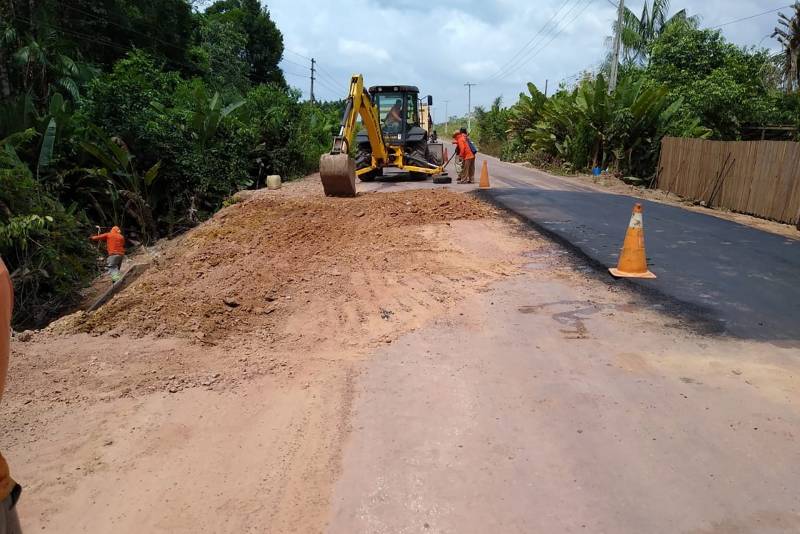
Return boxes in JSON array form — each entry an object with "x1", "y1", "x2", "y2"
[{"x1": 81, "y1": 189, "x2": 492, "y2": 343}]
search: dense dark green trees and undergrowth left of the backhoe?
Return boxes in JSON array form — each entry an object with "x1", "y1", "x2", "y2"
[{"x1": 0, "y1": 0, "x2": 340, "y2": 327}]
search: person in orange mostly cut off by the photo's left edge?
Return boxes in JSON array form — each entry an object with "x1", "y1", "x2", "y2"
[{"x1": 0, "y1": 259, "x2": 22, "y2": 534}]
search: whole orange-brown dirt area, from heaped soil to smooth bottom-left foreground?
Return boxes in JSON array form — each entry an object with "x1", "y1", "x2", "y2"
[{"x1": 0, "y1": 177, "x2": 540, "y2": 533}]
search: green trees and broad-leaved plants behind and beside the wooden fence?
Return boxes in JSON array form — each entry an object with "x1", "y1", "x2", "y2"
[{"x1": 468, "y1": 1, "x2": 800, "y2": 182}]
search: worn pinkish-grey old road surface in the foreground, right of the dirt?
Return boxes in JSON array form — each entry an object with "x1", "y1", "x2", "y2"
[{"x1": 328, "y1": 276, "x2": 800, "y2": 534}]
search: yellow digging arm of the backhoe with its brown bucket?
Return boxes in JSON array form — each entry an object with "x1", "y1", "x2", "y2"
[{"x1": 319, "y1": 74, "x2": 389, "y2": 197}]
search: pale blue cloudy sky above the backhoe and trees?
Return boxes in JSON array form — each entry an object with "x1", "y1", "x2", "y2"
[{"x1": 266, "y1": 0, "x2": 790, "y2": 119}]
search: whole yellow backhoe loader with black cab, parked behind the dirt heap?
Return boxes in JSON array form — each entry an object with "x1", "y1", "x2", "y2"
[{"x1": 319, "y1": 74, "x2": 449, "y2": 197}]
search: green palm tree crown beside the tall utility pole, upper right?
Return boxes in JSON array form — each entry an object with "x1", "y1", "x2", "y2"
[{"x1": 622, "y1": 0, "x2": 700, "y2": 63}]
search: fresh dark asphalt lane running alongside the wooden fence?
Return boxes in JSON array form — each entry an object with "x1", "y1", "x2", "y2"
[{"x1": 484, "y1": 158, "x2": 800, "y2": 346}]
